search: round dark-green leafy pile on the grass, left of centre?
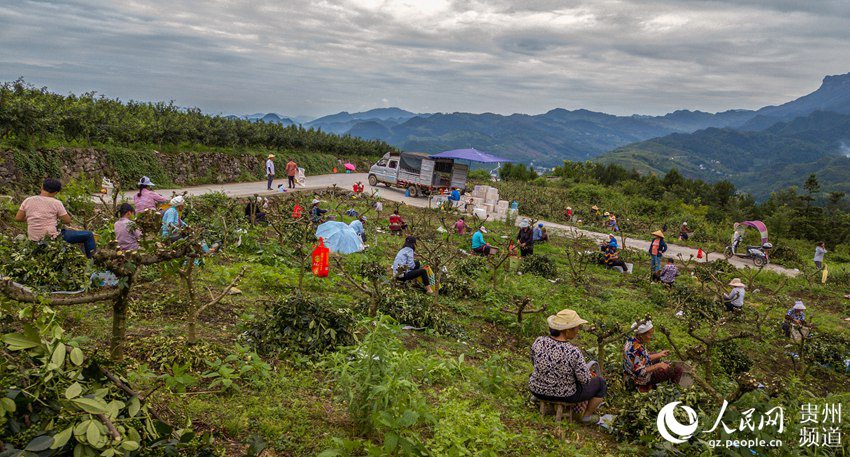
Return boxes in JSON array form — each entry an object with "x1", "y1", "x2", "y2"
[{"x1": 244, "y1": 293, "x2": 355, "y2": 355}]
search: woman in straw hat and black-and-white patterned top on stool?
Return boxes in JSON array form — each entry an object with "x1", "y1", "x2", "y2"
[{"x1": 528, "y1": 309, "x2": 608, "y2": 424}]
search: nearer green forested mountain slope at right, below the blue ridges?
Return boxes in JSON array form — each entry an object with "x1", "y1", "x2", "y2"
[{"x1": 599, "y1": 112, "x2": 850, "y2": 198}]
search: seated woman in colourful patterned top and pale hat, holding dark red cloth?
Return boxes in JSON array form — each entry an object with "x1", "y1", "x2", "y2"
[{"x1": 623, "y1": 320, "x2": 684, "y2": 392}]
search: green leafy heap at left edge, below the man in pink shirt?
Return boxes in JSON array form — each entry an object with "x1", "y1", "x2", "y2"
[{"x1": 0, "y1": 236, "x2": 90, "y2": 291}]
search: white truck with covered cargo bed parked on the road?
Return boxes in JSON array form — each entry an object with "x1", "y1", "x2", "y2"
[{"x1": 369, "y1": 152, "x2": 469, "y2": 197}]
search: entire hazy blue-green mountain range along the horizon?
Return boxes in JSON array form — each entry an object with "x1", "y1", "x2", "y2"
[{"x1": 234, "y1": 73, "x2": 850, "y2": 196}]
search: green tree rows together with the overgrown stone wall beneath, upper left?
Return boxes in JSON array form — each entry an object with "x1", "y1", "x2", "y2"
[{"x1": 0, "y1": 80, "x2": 392, "y2": 192}]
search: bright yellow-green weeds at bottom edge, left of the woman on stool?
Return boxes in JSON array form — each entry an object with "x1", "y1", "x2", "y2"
[{"x1": 428, "y1": 390, "x2": 512, "y2": 457}]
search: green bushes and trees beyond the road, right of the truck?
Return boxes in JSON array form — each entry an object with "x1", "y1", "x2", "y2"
[{"x1": 496, "y1": 162, "x2": 850, "y2": 260}]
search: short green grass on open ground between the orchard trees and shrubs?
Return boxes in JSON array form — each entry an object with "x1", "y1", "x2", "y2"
[{"x1": 13, "y1": 191, "x2": 848, "y2": 456}]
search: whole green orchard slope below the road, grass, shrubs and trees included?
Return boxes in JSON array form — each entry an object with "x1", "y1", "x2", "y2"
[{"x1": 0, "y1": 183, "x2": 850, "y2": 456}]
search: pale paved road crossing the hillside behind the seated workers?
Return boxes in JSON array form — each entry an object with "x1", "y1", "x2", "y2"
[{"x1": 137, "y1": 173, "x2": 800, "y2": 277}]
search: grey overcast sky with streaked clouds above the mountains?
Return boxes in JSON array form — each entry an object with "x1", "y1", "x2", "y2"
[{"x1": 0, "y1": 0, "x2": 850, "y2": 116}]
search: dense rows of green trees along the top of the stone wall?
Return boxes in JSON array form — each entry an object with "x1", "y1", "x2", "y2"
[{"x1": 0, "y1": 80, "x2": 391, "y2": 156}]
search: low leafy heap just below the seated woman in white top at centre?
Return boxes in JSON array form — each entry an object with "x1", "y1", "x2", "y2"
[{"x1": 378, "y1": 289, "x2": 458, "y2": 334}]
